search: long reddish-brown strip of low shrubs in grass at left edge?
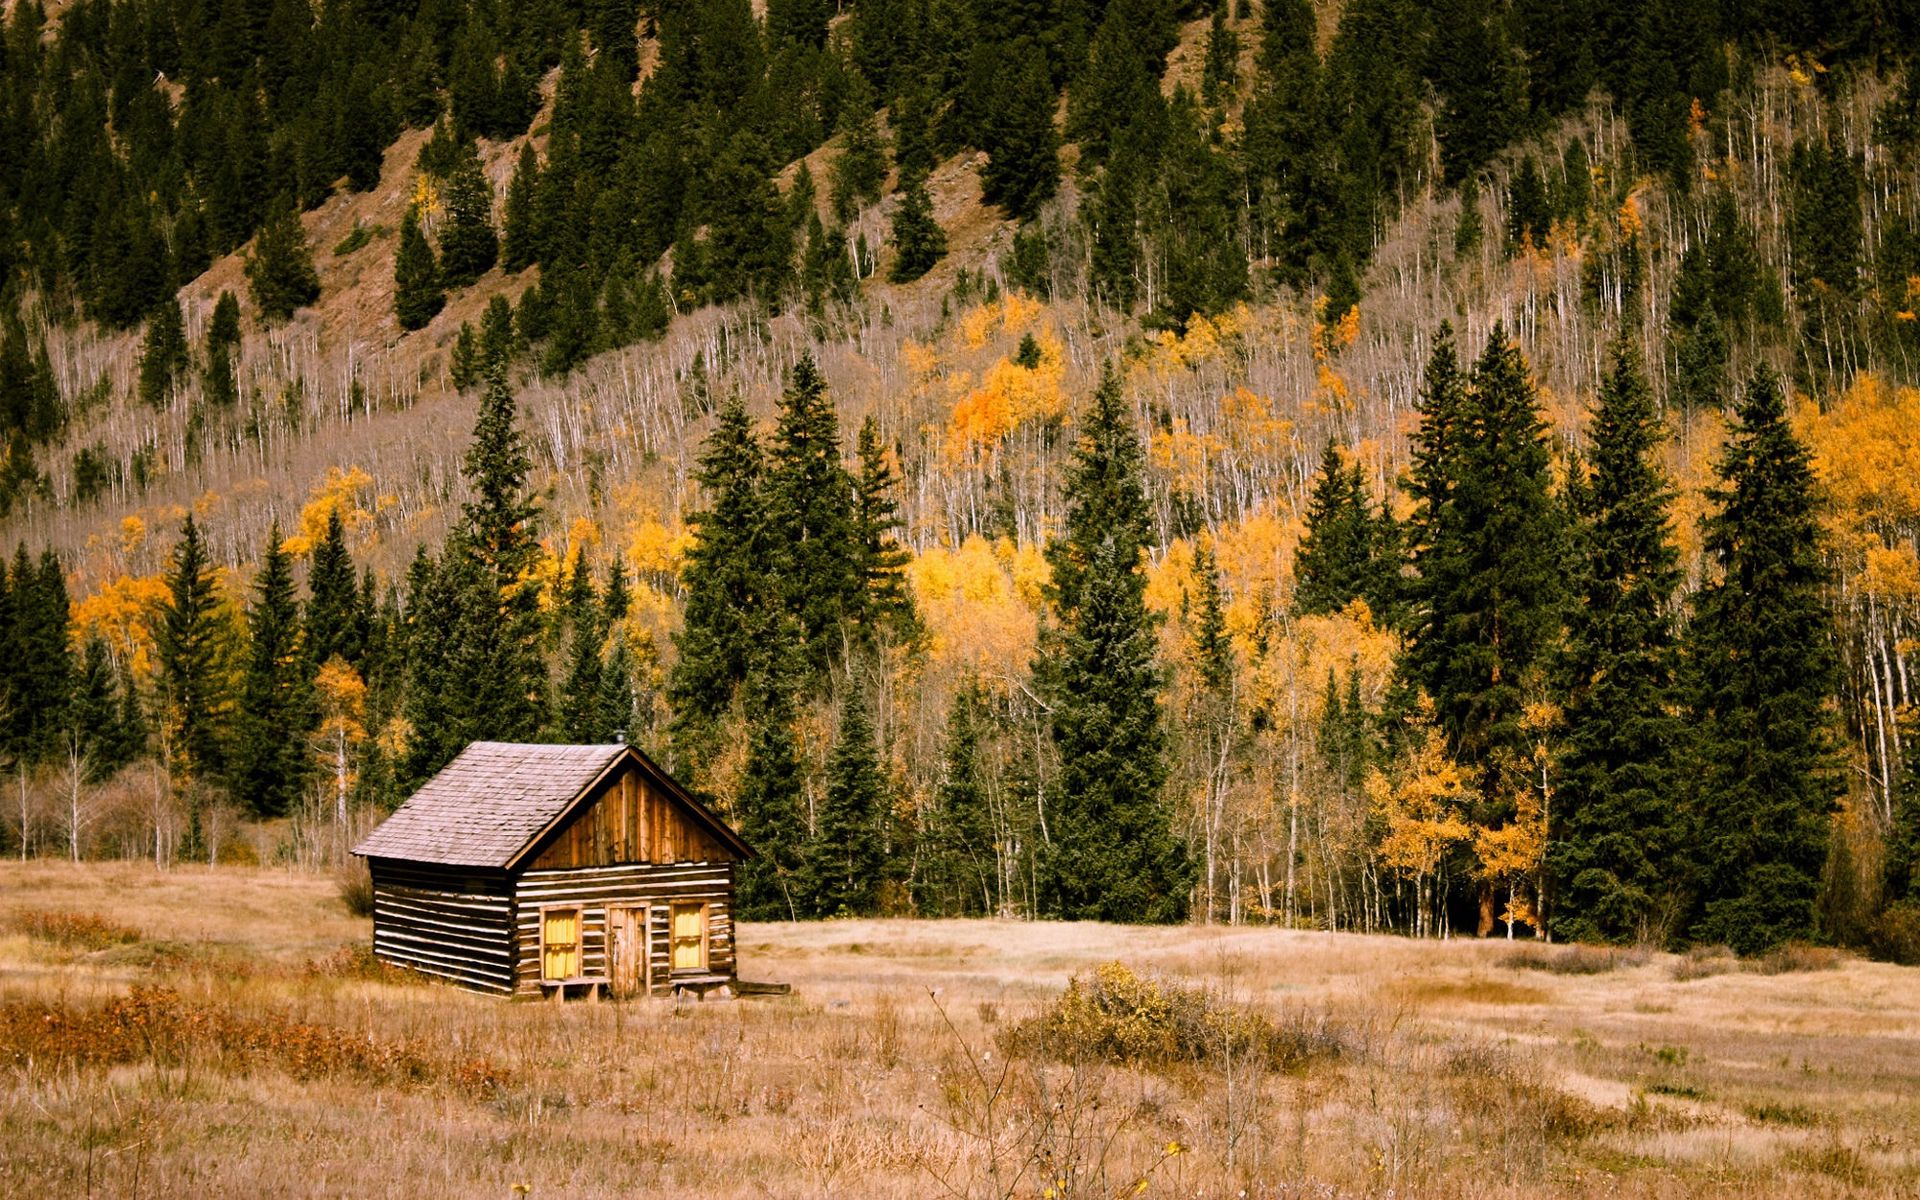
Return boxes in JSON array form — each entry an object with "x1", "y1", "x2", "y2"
[{"x1": 0, "y1": 987, "x2": 507, "y2": 1094}]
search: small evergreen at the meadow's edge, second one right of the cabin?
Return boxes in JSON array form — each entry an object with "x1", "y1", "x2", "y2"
[{"x1": 806, "y1": 689, "x2": 889, "y2": 916}]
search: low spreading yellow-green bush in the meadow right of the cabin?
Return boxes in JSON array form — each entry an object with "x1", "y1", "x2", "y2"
[{"x1": 1010, "y1": 962, "x2": 1344, "y2": 1071}]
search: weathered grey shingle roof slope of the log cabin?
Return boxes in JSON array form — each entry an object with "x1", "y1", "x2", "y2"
[{"x1": 353, "y1": 741, "x2": 630, "y2": 868}]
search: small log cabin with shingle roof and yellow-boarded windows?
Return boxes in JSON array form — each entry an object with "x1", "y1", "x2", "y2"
[{"x1": 353, "y1": 741, "x2": 753, "y2": 998}]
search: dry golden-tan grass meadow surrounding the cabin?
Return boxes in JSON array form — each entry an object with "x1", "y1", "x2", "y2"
[{"x1": 0, "y1": 862, "x2": 1920, "y2": 1200}]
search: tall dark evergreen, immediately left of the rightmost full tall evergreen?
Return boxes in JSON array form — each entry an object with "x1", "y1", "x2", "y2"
[{"x1": 1548, "y1": 342, "x2": 1686, "y2": 943}]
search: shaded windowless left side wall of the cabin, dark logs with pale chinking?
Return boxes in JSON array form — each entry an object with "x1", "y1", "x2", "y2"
[{"x1": 367, "y1": 858, "x2": 515, "y2": 993}]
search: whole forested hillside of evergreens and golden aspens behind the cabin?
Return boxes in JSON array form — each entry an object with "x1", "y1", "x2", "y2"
[{"x1": 0, "y1": 0, "x2": 1920, "y2": 956}]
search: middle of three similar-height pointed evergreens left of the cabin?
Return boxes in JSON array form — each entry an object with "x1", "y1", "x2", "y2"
[{"x1": 232, "y1": 524, "x2": 319, "y2": 818}]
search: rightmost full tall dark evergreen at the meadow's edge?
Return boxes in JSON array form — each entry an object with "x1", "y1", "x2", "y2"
[{"x1": 1686, "y1": 369, "x2": 1839, "y2": 954}]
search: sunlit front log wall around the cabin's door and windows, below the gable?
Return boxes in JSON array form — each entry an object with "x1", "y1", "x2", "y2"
[{"x1": 513, "y1": 862, "x2": 735, "y2": 996}]
